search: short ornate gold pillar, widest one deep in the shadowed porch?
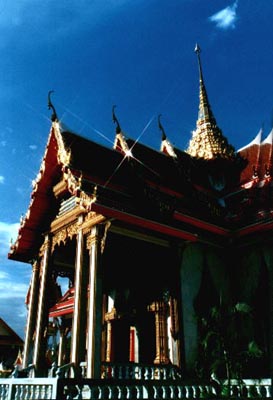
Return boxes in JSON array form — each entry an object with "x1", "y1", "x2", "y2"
[{"x1": 151, "y1": 301, "x2": 170, "y2": 364}]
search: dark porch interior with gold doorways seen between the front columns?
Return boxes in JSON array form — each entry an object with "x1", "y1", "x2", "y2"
[{"x1": 45, "y1": 232, "x2": 179, "y2": 374}]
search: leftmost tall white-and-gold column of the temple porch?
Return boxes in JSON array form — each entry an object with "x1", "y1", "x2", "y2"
[{"x1": 23, "y1": 261, "x2": 39, "y2": 368}]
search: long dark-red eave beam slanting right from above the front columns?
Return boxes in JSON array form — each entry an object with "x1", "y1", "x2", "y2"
[{"x1": 92, "y1": 203, "x2": 198, "y2": 242}]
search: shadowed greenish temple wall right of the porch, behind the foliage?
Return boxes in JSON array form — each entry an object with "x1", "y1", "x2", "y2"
[{"x1": 180, "y1": 243, "x2": 273, "y2": 377}]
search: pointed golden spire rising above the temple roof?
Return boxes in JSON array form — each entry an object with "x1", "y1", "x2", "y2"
[{"x1": 187, "y1": 44, "x2": 235, "y2": 160}]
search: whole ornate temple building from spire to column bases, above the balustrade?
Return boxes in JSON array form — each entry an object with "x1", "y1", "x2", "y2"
[{"x1": 9, "y1": 47, "x2": 273, "y2": 378}]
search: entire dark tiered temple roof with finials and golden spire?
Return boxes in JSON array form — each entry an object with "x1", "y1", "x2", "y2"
[{"x1": 6, "y1": 46, "x2": 273, "y2": 262}]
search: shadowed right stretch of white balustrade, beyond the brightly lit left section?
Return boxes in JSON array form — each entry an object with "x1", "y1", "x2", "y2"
[{"x1": 58, "y1": 379, "x2": 272, "y2": 400}]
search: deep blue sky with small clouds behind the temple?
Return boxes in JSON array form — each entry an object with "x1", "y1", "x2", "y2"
[{"x1": 0, "y1": 0, "x2": 273, "y2": 337}]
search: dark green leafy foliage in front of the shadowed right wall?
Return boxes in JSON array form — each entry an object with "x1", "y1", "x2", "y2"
[{"x1": 197, "y1": 303, "x2": 263, "y2": 380}]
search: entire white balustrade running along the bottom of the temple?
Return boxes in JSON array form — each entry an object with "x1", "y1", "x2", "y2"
[{"x1": 0, "y1": 363, "x2": 273, "y2": 400}]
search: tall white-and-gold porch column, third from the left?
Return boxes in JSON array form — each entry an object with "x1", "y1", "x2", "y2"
[{"x1": 71, "y1": 216, "x2": 87, "y2": 366}]
